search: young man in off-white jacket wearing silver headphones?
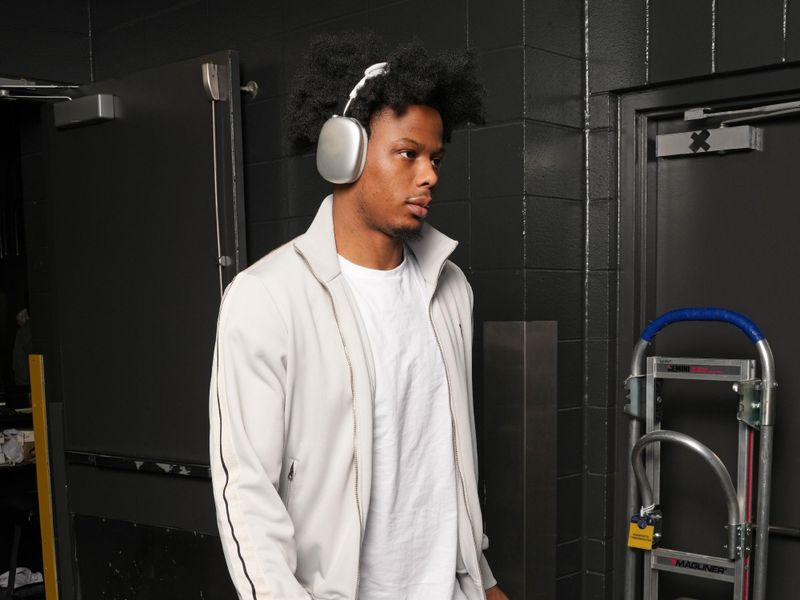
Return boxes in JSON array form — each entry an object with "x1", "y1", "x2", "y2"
[{"x1": 210, "y1": 35, "x2": 505, "y2": 600}]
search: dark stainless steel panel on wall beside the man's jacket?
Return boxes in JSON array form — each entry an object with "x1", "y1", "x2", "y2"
[{"x1": 482, "y1": 321, "x2": 556, "y2": 600}]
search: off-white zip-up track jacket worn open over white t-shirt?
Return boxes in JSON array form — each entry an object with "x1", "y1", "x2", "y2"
[{"x1": 210, "y1": 196, "x2": 495, "y2": 600}]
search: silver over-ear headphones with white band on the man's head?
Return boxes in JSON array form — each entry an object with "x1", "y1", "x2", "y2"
[{"x1": 317, "y1": 63, "x2": 389, "y2": 183}]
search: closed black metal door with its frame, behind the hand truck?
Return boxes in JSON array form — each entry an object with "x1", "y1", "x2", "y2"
[{"x1": 618, "y1": 71, "x2": 800, "y2": 600}]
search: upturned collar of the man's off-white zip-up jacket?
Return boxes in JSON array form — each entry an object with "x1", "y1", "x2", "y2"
[{"x1": 294, "y1": 195, "x2": 458, "y2": 284}]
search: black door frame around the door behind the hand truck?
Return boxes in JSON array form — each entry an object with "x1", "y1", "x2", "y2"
[{"x1": 609, "y1": 64, "x2": 800, "y2": 598}]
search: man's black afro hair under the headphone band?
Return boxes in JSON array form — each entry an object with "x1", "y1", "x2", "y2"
[{"x1": 287, "y1": 31, "x2": 485, "y2": 154}]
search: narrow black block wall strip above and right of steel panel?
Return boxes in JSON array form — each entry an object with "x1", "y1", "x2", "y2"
[{"x1": 524, "y1": 0, "x2": 585, "y2": 599}]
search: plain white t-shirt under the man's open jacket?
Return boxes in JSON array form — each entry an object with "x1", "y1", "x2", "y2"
[{"x1": 339, "y1": 248, "x2": 466, "y2": 600}]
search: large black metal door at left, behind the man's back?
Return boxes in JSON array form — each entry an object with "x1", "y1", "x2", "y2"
[{"x1": 44, "y1": 52, "x2": 245, "y2": 598}]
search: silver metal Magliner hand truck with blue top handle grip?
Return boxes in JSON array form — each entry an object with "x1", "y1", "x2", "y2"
[{"x1": 624, "y1": 308, "x2": 777, "y2": 600}]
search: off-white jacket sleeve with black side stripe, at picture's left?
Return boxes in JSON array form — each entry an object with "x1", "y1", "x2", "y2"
[{"x1": 209, "y1": 273, "x2": 310, "y2": 600}]
